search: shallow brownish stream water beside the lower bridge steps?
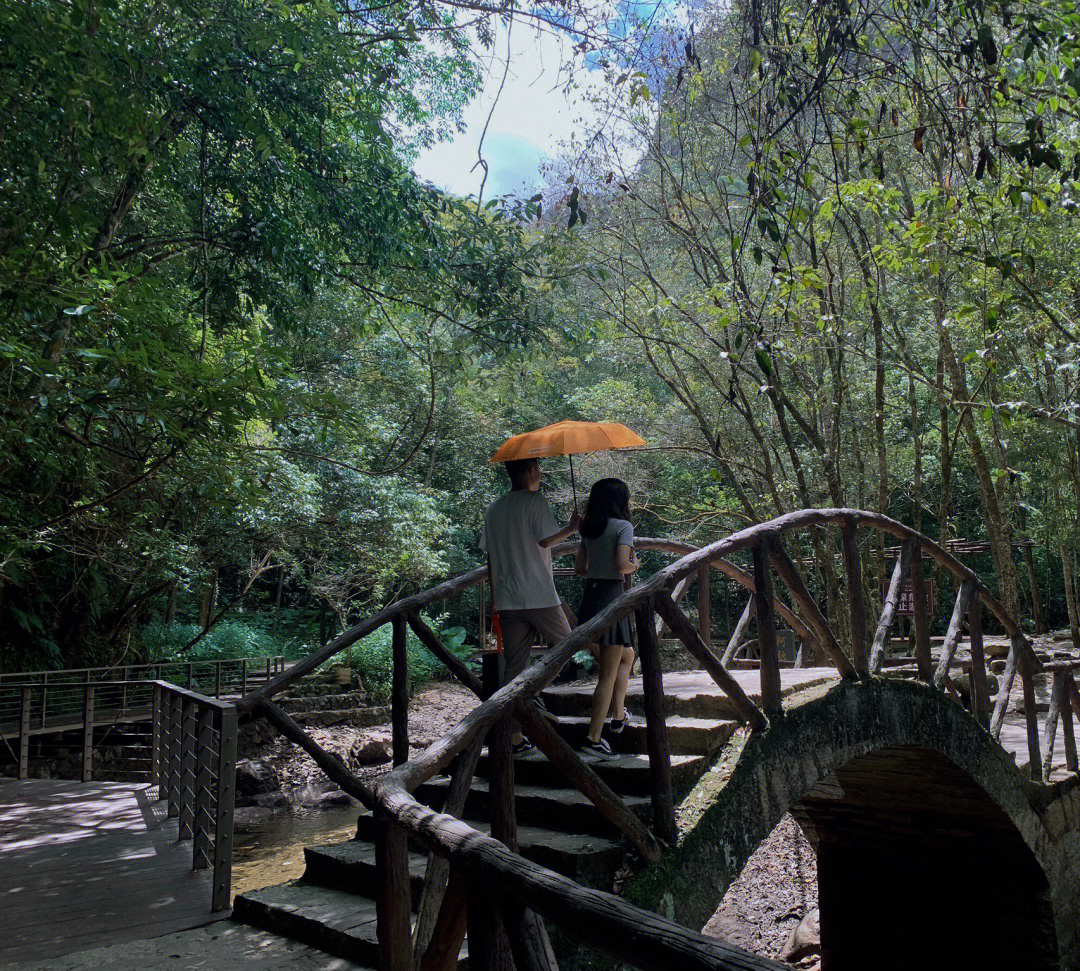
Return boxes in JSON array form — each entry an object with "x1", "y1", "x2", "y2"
[{"x1": 232, "y1": 807, "x2": 360, "y2": 893}]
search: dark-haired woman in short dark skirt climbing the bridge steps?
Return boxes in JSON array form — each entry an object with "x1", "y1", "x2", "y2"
[{"x1": 573, "y1": 478, "x2": 640, "y2": 759}]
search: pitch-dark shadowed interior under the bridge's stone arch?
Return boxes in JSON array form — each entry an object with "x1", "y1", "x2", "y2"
[{"x1": 792, "y1": 746, "x2": 1059, "y2": 971}]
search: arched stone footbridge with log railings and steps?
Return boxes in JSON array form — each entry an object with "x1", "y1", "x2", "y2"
[{"x1": 221, "y1": 509, "x2": 1080, "y2": 971}]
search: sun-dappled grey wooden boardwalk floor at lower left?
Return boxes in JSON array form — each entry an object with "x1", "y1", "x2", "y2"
[{"x1": 0, "y1": 780, "x2": 228, "y2": 965}]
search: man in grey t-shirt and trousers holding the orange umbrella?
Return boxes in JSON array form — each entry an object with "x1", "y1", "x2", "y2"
[{"x1": 480, "y1": 459, "x2": 581, "y2": 755}]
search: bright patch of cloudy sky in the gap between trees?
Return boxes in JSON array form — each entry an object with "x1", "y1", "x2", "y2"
[{"x1": 413, "y1": 22, "x2": 603, "y2": 200}]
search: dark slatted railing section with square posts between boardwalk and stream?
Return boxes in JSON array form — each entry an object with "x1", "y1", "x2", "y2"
[{"x1": 151, "y1": 682, "x2": 237, "y2": 911}]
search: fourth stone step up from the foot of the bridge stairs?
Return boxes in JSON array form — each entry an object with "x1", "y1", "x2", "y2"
[{"x1": 416, "y1": 763, "x2": 652, "y2": 839}]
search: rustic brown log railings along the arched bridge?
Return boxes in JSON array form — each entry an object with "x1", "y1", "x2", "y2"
[{"x1": 232, "y1": 509, "x2": 1067, "y2": 971}]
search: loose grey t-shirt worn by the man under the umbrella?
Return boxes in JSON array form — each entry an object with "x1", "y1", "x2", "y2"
[{"x1": 480, "y1": 489, "x2": 559, "y2": 610}]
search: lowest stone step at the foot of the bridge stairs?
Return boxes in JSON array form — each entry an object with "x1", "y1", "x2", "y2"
[{"x1": 232, "y1": 881, "x2": 379, "y2": 968}]
